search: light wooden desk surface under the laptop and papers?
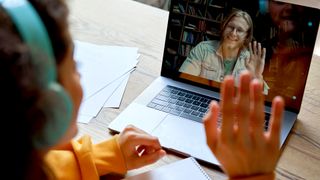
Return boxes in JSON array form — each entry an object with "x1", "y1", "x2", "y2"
[{"x1": 67, "y1": 0, "x2": 320, "y2": 179}]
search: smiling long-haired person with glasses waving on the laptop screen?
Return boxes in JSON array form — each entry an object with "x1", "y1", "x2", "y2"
[{"x1": 179, "y1": 10, "x2": 268, "y2": 94}]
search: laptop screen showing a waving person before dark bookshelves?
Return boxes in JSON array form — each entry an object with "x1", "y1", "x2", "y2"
[{"x1": 161, "y1": 0, "x2": 320, "y2": 112}]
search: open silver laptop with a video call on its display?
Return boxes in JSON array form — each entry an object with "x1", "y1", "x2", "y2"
[{"x1": 108, "y1": 0, "x2": 320, "y2": 166}]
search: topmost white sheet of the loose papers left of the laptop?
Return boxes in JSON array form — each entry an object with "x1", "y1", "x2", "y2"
[{"x1": 75, "y1": 41, "x2": 138, "y2": 100}]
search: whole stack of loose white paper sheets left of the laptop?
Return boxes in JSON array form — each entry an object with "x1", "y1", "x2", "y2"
[{"x1": 74, "y1": 41, "x2": 139, "y2": 123}]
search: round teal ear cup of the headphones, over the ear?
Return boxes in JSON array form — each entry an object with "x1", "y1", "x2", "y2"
[{"x1": 33, "y1": 82, "x2": 72, "y2": 149}]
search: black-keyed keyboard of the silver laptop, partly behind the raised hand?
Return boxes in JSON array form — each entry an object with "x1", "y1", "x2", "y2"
[{"x1": 147, "y1": 85, "x2": 270, "y2": 130}]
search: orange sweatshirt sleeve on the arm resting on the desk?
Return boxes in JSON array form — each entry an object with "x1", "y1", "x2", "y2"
[{"x1": 45, "y1": 135, "x2": 127, "y2": 180}]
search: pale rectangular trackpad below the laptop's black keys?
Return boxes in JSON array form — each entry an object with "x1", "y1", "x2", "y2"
[{"x1": 152, "y1": 115, "x2": 218, "y2": 164}]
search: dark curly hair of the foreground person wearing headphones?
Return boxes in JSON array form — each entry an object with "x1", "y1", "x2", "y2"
[{"x1": 0, "y1": 0, "x2": 72, "y2": 179}]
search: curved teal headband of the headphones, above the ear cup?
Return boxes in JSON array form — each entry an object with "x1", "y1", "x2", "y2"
[{"x1": 0, "y1": 0, "x2": 57, "y2": 85}]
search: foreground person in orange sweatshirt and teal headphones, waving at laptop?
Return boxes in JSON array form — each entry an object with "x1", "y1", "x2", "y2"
[{"x1": 0, "y1": 0, "x2": 283, "y2": 179}]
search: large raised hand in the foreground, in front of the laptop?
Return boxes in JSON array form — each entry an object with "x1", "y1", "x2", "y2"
[{"x1": 204, "y1": 72, "x2": 284, "y2": 178}]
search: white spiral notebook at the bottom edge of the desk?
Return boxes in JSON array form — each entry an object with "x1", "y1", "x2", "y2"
[{"x1": 125, "y1": 157, "x2": 211, "y2": 180}]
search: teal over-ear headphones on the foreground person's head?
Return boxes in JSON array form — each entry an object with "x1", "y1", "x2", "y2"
[{"x1": 0, "y1": 0, "x2": 72, "y2": 149}]
